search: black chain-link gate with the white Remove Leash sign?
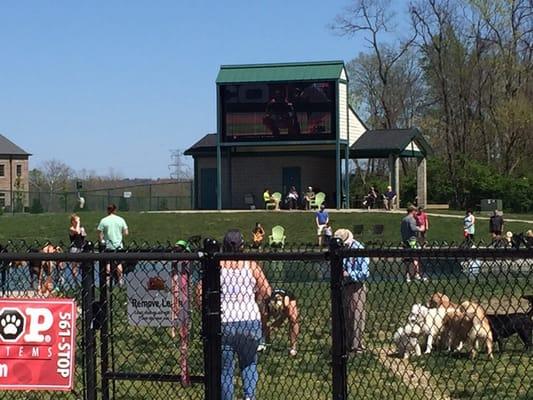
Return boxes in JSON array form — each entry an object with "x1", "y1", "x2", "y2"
[{"x1": 94, "y1": 254, "x2": 205, "y2": 400}]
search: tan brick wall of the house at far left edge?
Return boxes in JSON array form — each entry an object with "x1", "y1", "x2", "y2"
[{"x1": 0, "y1": 156, "x2": 29, "y2": 207}]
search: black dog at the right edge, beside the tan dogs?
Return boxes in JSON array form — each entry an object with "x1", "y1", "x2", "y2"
[{"x1": 487, "y1": 295, "x2": 533, "y2": 351}]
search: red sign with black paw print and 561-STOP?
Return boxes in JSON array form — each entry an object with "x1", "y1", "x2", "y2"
[{"x1": 0, "y1": 299, "x2": 76, "y2": 390}]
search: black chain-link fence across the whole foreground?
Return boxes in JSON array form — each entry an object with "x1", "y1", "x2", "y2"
[{"x1": 0, "y1": 237, "x2": 533, "y2": 400}]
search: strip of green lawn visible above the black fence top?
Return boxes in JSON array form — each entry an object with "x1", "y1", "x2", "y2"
[{"x1": 0, "y1": 211, "x2": 533, "y2": 243}]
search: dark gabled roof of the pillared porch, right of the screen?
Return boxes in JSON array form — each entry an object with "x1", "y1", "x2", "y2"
[{"x1": 350, "y1": 128, "x2": 433, "y2": 158}]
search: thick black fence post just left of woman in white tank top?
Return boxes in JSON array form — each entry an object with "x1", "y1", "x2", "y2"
[{"x1": 202, "y1": 239, "x2": 222, "y2": 400}]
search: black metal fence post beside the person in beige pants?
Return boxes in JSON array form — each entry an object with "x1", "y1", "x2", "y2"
[{"x1": 329, "y1": 239, "x2": 348, "y2": 400}]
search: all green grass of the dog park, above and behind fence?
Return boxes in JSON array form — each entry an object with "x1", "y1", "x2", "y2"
[{"x1": 0, "y1": 212, "x2": 533, "y2": 400}]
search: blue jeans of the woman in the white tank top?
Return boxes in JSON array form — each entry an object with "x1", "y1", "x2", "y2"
[{"x1": 222, "y1": 321, "x2": 261, "y2": 400}]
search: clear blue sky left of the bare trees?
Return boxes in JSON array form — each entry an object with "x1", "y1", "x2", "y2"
[{"x1": 0, "y1": 0, "x2": 406, "y2": 178}]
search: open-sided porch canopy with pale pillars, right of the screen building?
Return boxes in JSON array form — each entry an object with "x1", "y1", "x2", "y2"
[{"x1": 350, "y1": 128, "x2": 433, "y2": 207}]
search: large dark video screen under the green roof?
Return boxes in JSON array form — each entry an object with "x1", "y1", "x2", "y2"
[{"x1": 220, "y1": 82, "x2": 336, "y2": 141}]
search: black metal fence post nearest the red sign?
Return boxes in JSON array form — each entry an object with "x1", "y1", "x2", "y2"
[{"x1": 81, "y1": 242, "x2": 97, "y2": 400}]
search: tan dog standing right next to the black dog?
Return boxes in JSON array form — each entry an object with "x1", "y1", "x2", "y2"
[{"x1": 444, "y1": 301, "x2": 493, "y2": 359}]
